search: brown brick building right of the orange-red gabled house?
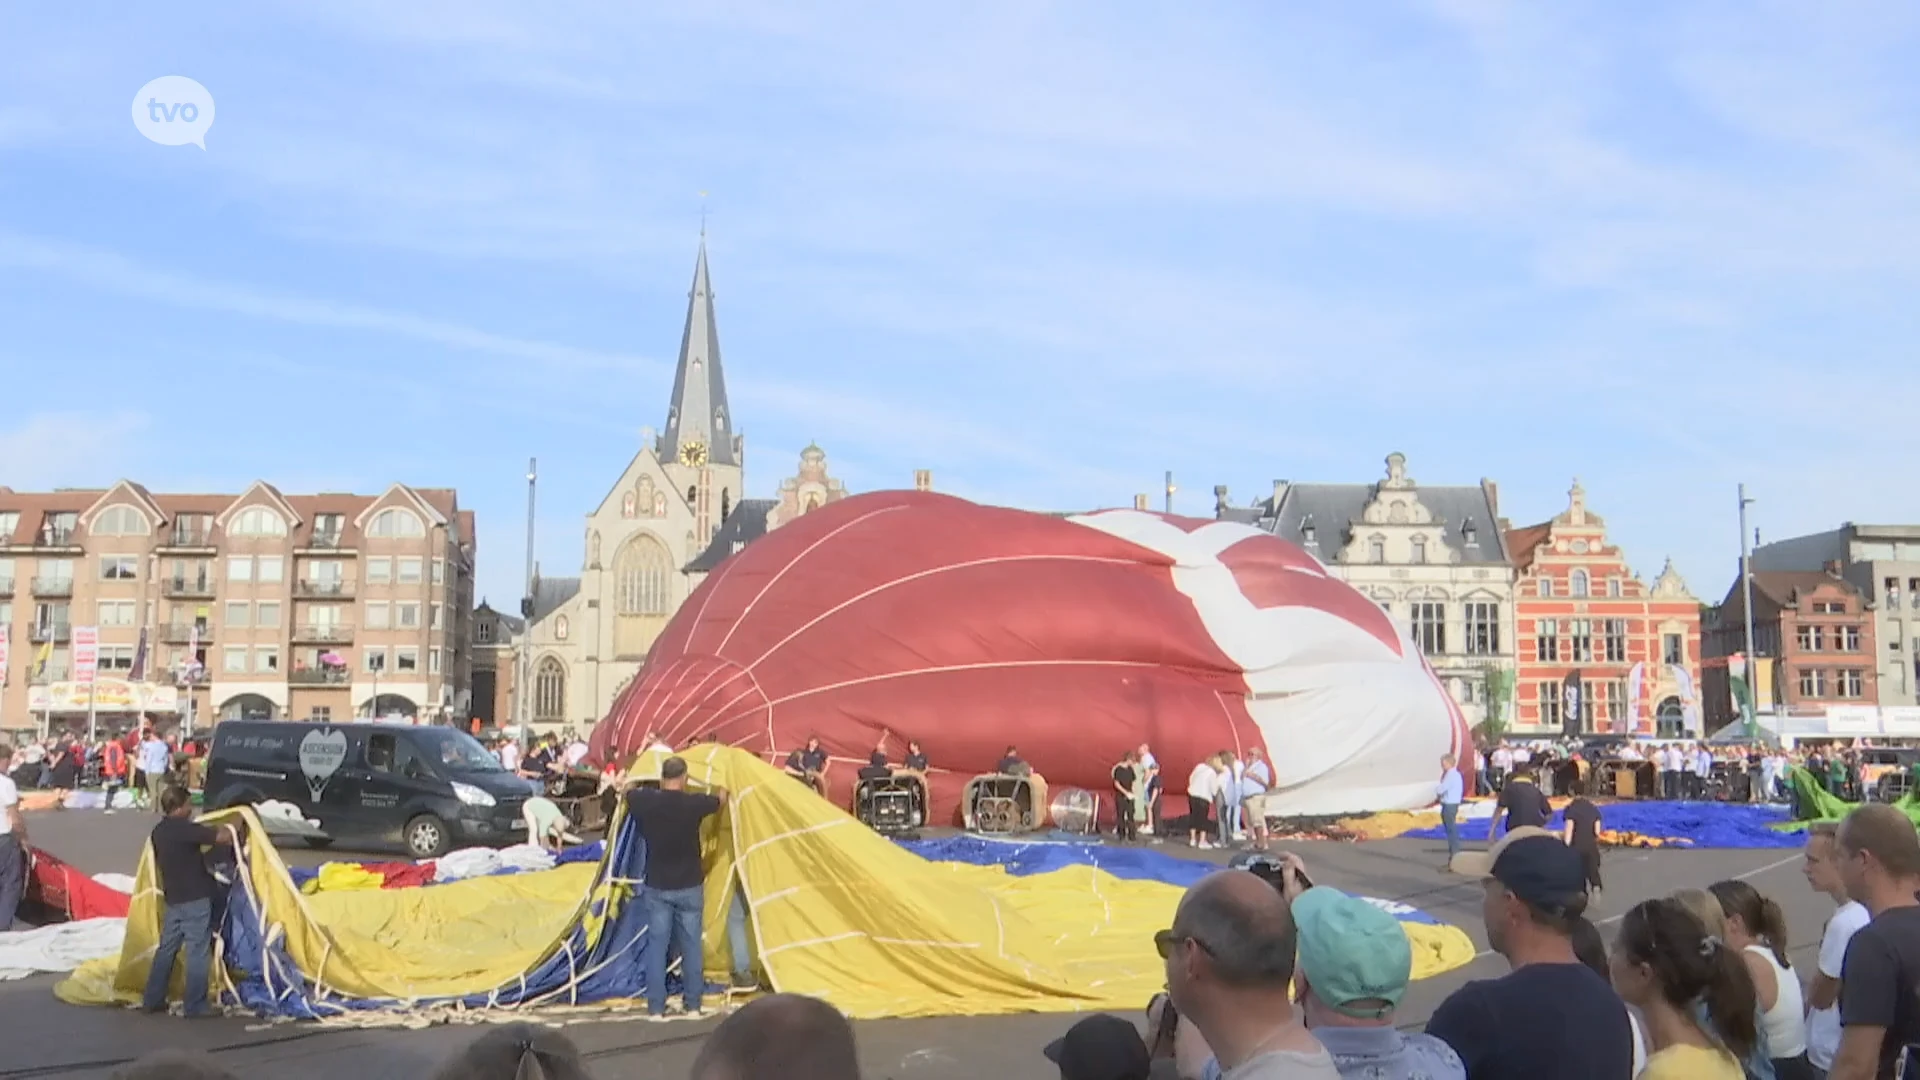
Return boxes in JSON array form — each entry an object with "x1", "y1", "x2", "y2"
[{"x1": 1701, "y1": 561, "x2": 1880, "y2": 724}]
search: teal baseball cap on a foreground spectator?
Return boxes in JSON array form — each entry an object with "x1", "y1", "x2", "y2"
[{"x1": 1292, "y1": 886, "x2": 1413, "y2": 1020}]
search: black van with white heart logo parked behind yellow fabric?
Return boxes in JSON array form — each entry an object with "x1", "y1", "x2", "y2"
[{"x1": 205, "y1": 721, "x2": 536, "y2": 859}]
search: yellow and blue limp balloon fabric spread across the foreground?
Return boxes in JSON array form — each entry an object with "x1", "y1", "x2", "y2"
[{"x1": 56, "y1": 746, "x2": 1473, "y2": 1019}]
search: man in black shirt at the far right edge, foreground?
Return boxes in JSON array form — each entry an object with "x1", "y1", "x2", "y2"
[{"x1": 1828, "y1": 803, "x2": 1920, "y2": 1080}]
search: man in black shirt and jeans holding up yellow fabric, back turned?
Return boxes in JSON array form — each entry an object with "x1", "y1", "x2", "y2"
[{"x1": 626, "y1": 757, "x2": 721, "y2": 1017}]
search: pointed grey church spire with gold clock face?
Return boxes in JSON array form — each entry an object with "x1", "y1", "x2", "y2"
[{"x1": 653, "y1": 231, "x2": 747, "y2": 538}]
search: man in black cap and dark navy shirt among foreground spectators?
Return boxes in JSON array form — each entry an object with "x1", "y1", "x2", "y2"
[{"x1": 1427, "y1": 826, "x2": 1634, "y2": 1080}]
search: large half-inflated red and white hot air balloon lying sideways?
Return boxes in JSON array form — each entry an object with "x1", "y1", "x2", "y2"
[{"x1": 593, "y1": 492, "x2": 1469, "y2": 821}]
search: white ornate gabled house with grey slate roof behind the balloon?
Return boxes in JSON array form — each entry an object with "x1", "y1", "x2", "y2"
[{"x1": 1213, "y1": 454, "x2": 1515, "y2": 724}]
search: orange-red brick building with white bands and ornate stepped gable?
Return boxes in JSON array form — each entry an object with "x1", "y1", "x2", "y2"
[{"x1": 1507, "y1": 480, "x2": 1701, "y2": 734}]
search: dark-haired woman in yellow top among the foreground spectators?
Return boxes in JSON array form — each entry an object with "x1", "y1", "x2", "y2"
[{"x1": 1609, "y1": 899, "x2": 1761, "y2": 1080}]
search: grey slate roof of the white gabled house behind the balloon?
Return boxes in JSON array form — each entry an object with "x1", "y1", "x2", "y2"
[{"x1": 1259, "y1": 484, "x2": 1507, "y2": 565}]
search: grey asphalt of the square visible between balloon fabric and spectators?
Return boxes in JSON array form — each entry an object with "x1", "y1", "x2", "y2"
[{"x1": 0, "y1": 811, "x2": 1832, "y2": 1080}]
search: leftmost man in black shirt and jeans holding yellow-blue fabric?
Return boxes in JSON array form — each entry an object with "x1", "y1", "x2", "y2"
[{"x1": 140, "y1": 786, "x2": 236, "y2": 1019}]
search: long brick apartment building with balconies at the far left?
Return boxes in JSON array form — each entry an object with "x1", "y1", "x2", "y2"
[{"x1": 0, "y1": 480, "x2": 474, "y2": 732}]
